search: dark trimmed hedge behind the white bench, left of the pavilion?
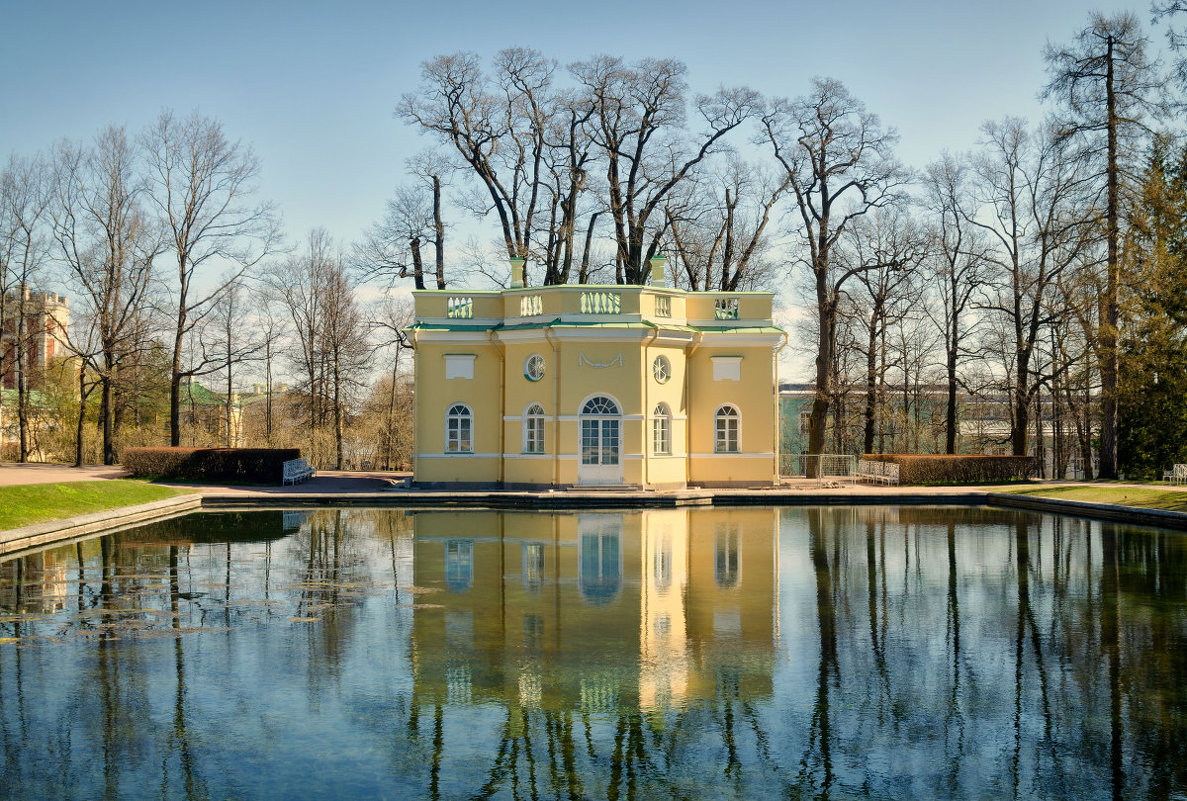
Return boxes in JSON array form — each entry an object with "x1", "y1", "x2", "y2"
[{"x1": 122, "y1": 447, "x2": 300, "y2": 484}]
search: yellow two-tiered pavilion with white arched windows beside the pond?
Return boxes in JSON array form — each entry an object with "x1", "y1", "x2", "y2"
[{"x1": 408, "y1": 259, "x2": 786, "y2": 489}]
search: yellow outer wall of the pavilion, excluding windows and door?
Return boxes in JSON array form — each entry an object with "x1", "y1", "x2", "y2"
[{"x1": 412, "y1": 286, "x2": 781, "y2": 488}]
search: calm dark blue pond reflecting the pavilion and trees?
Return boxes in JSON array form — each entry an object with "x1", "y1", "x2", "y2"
[{"x1": 0, "y1": 507, "x2": 1187, "y2": 799}]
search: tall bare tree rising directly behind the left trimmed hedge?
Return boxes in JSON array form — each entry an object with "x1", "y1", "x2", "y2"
[{"x1": 142, "y1": 110, "x2": 279, "y2": 445}]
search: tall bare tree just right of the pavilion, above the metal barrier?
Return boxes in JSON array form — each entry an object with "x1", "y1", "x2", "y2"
[{"x1": 762, "y1": 78, "x2": 909, "y2": 453}]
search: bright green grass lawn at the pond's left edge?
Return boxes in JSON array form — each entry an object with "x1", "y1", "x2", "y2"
[{"x1": 0, "y1": 478, "x2": 190, "y2": 532}]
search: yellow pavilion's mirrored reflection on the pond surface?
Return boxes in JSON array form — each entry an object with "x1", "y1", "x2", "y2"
[{"x1": 412, "y1": 509, "x2": 777, "y2": 712}]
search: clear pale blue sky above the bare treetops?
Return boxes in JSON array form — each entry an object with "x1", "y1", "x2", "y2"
[{"x1": 0, "y1": 0, "x2": 1162, "y2": 252}]
